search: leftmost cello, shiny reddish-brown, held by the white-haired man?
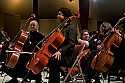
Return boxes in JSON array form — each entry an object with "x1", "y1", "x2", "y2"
[{"x1": 5, "y1": 14, "x2": 35, "y2": 68}]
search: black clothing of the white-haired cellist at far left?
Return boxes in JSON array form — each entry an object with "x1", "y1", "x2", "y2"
[{"x1": 3, "y1": 31, "x2": 44, "y2": 82}]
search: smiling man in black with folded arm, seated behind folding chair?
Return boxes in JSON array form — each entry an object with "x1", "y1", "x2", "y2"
[{"x1": 78, "y1": 29, "x2": 98, "y2": 83}]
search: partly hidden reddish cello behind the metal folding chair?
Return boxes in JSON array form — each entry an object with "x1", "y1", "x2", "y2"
[{"x1": 61, "y1": 34, "x2": 97, "y2": 76}]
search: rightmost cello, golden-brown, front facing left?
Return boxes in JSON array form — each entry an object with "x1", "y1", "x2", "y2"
[{"x1": 91, "y1": 17, "x2": 125, "y2": 72}]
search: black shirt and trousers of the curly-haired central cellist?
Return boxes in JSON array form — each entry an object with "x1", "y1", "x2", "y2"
[{"x1": 48, "y1": 24, "x2": 77, "y2": 83}]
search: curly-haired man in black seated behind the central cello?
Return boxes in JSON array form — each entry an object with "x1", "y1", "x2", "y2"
[{"x1": 48, "y1": 7, "x2": 77, "y2": 83}]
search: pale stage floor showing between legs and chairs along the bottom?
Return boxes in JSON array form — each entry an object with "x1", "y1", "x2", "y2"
[{"x1": 0, "y1": 71, "x2": 123, "y2": 83}]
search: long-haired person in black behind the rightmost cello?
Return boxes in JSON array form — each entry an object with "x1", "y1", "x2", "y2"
[{"x1": 83, "y1": 22, "x2": 112, "y2": 83}]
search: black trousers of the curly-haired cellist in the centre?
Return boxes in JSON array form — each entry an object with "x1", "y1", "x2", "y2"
[{"x1": 48, "y1": 57, "x2": 74, "y2": 83}]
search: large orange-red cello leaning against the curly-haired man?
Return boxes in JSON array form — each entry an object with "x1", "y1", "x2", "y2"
[{"x1": 26, "y1": 14, "x2": 79, "y2": 74}]
